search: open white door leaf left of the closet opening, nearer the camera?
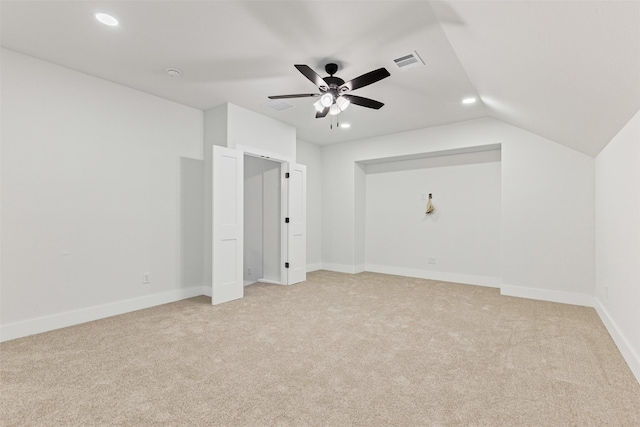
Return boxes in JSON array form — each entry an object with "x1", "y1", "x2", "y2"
[{"x1": 211, "y1": 145, "x2": 244, "y2": 304}]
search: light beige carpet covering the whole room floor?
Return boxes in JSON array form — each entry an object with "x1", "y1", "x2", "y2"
[{"x1": 0, "y1": 271, "x2": 640, "y2": 426}]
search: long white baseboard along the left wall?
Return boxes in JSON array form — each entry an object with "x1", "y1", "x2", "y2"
[{"x1": 0, "y1": 286, "x2": 205, "y2": 342}]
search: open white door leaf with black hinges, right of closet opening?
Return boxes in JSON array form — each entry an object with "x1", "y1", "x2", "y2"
[{"x1": 285, "y1": 163, "x2": 307, "y2": 285}]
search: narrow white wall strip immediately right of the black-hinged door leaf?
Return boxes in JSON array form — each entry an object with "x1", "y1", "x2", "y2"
[{"x1": 296, "y1": 139, "x2": 323, "y2": 271}]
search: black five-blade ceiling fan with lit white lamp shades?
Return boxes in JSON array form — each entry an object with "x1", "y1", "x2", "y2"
[{"x1": 269, "y1": 63, "x2": 390, "y2": 119}]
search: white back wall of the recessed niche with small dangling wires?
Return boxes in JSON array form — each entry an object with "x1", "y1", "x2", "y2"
[{"x1": 366, "y1": 150, "x2": 502, "y2": 287}]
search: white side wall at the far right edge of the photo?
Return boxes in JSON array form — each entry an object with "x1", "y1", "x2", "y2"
[{"x1": 595, "y1": 112, "x2": 640, "y2": 379}]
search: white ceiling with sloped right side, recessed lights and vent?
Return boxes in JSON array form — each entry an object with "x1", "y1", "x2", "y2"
[{"x1": 0, "y1": 0, "x2": 640, "y2": 156}]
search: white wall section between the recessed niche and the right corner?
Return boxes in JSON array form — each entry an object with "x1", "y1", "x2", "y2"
[{"x1": 502, "y1": 124, "x2": 595, "y2": 306}]
